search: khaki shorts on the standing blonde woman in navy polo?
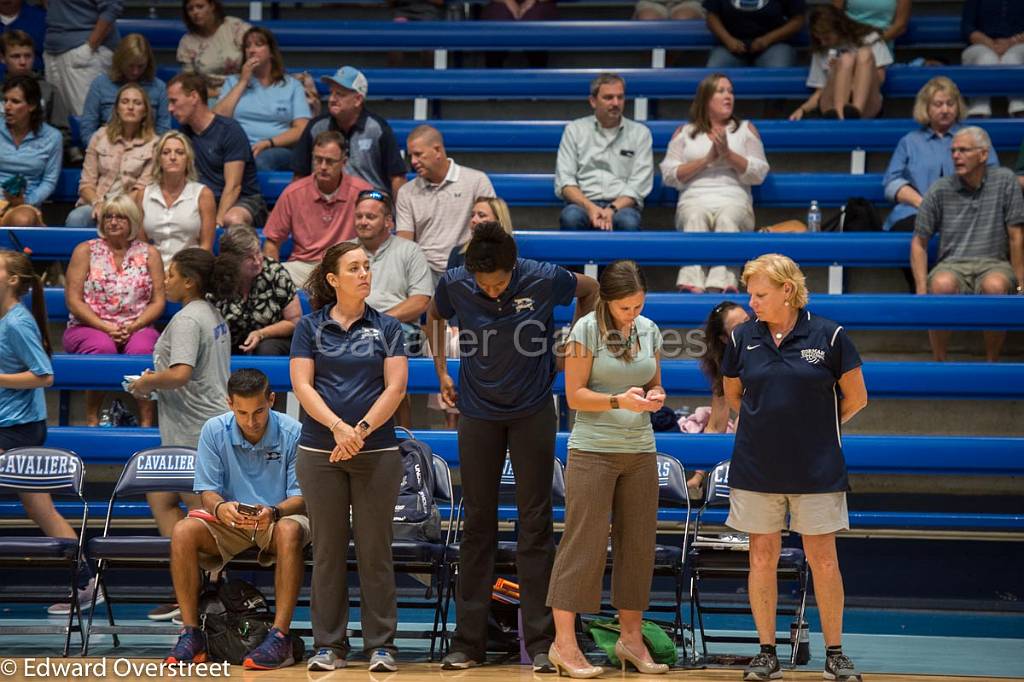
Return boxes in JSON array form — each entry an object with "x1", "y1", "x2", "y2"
[{"x1": 725, "y1": 487, "x2": 850, "y2": 536}]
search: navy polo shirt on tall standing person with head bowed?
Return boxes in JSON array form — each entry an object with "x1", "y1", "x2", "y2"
[{"x1": 434, "y1": 258, "x2": 577, "y2": 420}]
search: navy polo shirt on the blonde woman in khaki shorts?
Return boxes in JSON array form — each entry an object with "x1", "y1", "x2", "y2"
[{"x1": 722, "y1": 309, "x2": 861, "y2": 495}]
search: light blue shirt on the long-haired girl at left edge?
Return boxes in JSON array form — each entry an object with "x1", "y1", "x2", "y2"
[{"x1": 0, "y1": 303, "x2": 53, "y2": 428}]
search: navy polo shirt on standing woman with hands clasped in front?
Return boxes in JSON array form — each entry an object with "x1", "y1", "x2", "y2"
[{"x1": 292, "y1": 305, "x2": 406, "y2": 453}]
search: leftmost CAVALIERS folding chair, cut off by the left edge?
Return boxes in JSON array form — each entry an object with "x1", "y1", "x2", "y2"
[{"x1": 0, "y1": 447, "x2": 89, "y2": 656}]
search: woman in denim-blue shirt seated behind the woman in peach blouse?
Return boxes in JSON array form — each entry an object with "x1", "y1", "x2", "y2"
[{"x1": 81, "y1": 33, "x2": 171, "y2": 145}]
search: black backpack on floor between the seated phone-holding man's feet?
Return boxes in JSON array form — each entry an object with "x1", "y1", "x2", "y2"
[{"x1": 199, "y1": 580, "x2": 305, "y2": 666}]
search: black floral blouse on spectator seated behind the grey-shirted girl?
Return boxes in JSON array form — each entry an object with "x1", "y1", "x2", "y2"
[{"x1": 211, "y1": 256, "x2": 297, "y2": 348}]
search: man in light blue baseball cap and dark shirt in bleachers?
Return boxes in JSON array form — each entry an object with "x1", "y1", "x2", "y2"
[{"x1": 292, "y1": 67, "x2": 407, "y2": 197}]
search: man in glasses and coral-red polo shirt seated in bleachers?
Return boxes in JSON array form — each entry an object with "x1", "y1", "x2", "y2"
[{"x1": 263, "y1": 130, "x2": 373, "y2": 287}]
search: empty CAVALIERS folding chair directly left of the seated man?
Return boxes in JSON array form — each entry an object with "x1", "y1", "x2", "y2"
[{"x1": 82, "y1": 446, "x2": 196, "y2": 656}]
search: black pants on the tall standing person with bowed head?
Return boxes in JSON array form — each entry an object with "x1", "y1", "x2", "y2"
[{"x1": 452, "y1": 400, "x2": 557, "y2": 663}]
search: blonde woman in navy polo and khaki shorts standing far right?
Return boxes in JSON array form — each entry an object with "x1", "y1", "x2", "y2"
[{"x1": 722, "y1": 254, "x2": 867, "y2": 680}]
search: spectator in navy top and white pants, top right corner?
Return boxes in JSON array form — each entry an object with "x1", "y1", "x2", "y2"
[{"x1": 961, "y1": 0, "x2": 1024, "y2": 117}]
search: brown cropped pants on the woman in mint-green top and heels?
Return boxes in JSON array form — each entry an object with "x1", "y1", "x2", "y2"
[{"x1": 547, "y1": 450, "x2": 657, "y2": 613}]
